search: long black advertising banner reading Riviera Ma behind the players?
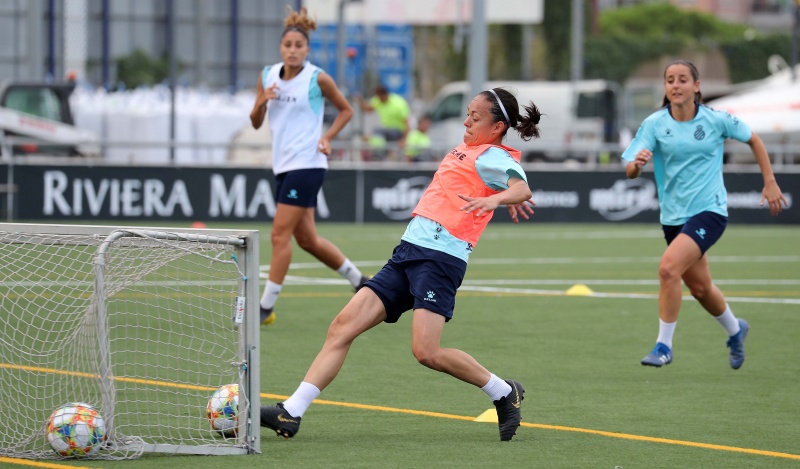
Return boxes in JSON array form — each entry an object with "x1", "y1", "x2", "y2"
[{"x1": 9, "y1": 165, "x2": 800, "y2": 224}]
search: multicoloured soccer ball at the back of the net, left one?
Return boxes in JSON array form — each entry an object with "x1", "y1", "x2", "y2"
[{"x1": 47, "y1": 402, "x2": 106, "y2": 458}]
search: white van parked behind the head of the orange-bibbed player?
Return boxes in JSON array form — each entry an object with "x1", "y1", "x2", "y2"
[{"x1": 427, "y1": 80, "x2": 620, "y2": 161}]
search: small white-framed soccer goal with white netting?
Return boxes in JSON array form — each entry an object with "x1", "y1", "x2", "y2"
[{"x1": 0, "y1": 223, "x2": 260, "y2": 459}]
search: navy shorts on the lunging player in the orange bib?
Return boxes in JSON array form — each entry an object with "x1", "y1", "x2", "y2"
[{"x1": 364, "y1": 241, "x2": 467, "y2": 323}]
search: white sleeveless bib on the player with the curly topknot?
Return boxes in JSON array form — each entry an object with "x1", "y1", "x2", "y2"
[{"x1": 262, "y1": 62, "x2": 328, "y2": 174}]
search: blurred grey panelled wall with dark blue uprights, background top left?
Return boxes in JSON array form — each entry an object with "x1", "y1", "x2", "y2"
[{"x1": 0, "y1": 0, "x2": 300, "y2": 89}]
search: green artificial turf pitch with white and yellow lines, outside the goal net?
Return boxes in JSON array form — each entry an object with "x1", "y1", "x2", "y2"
[{"x1": 0, "y1": 221, "x2": 800, "y2": 469}]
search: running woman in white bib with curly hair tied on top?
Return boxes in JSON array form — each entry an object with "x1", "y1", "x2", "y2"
[{"x1": 250, "y1": 8, "x2": 368, "y2": 324}]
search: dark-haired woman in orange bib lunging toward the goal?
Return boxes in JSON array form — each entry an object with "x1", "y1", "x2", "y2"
[{"x1": 261, "y1": 88, "x2": 541, "y2": 441}]
